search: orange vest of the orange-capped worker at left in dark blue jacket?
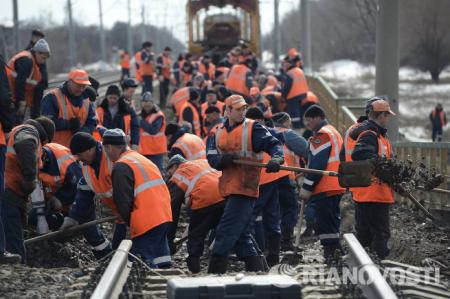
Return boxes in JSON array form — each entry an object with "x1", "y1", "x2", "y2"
[{"x1": 50, "y1": 88, "x2": 91, "y2": 147}]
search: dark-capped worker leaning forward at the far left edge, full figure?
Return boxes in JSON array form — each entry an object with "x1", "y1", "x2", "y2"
[{"x1": 0, "y1": 117, "x2": 55, "y2": 263}]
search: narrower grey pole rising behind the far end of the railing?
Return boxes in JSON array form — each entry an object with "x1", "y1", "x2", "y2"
[{"x1": 300, "y1": 0, "x2": 312, "y2": 74}]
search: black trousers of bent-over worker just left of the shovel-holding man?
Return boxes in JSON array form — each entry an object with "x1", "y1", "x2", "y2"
[{"x1": 187, "y1": 200, "x2": 226, "y2": 257}]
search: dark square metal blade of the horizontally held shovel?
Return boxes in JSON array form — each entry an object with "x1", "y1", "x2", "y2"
[{"x1": 338, "y1": 160, "x2": 374, "y2": 188}]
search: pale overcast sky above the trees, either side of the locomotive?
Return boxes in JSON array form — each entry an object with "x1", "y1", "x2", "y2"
[{"x1": 0, "y1": 0, "x2": 300, "y2": 41}]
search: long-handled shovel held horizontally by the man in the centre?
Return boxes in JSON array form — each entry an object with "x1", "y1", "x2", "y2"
[{"x1": 233, "y1": 160, "x2": 373, "y2": 188}]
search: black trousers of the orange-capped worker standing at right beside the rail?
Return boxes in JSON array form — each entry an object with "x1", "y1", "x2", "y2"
[{"x1": 355, "y1": 202, "x2": 391, "y2": 259}]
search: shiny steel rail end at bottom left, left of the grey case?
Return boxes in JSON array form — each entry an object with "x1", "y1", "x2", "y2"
[{"x1": 91, "y1": 240, "x2": 132, "y2": 299}]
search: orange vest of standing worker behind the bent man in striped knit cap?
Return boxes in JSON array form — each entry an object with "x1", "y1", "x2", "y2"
[{"x1": 139, "y1": 110, "x2": 167, "y2": 155}]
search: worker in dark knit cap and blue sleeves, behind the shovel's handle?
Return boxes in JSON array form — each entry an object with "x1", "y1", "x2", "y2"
[{"x1": 272, "y1": 112, "x2": 308, "y2": 250}]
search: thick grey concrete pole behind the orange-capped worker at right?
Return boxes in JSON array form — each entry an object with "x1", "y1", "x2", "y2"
[{"x1": 375, "y1": 0, "x2": 399, "y2": 141}]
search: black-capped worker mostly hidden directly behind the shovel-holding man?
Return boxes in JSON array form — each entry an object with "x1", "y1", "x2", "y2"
[{"x1": 245, "y1": 107, "x2": 290, "y2": 267}]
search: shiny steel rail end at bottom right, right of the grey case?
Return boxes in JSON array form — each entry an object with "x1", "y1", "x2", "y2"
[{"x1": 344, "y1": 234, "x2": 397, "y2": 299}]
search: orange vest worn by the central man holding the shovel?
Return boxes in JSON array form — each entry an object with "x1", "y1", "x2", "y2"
[{"x1": 215, "y1": 119, "x2": 263, "y2": 197}]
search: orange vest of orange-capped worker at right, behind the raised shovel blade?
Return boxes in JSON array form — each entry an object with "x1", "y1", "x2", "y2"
[{"x1": 351, "y1": 131, "x2": 394, "y2": 203}]
